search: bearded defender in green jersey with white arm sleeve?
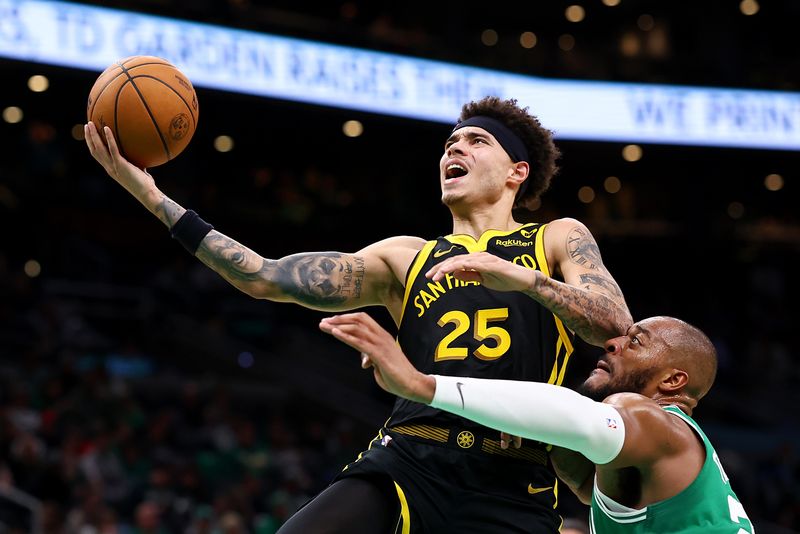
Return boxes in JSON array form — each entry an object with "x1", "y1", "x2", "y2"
[{"x1": 320, "y1": 313, "x2": 753, "y2": 534}]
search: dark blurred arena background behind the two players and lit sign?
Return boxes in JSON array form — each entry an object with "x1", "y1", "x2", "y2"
[{"x1": 0, "y1": 0, "x2": 800, "y2": 532}]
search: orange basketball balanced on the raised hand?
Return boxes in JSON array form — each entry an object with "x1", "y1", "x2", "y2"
[{"x1": 86, "y1": 56, "x2": 199, "y2": 168}]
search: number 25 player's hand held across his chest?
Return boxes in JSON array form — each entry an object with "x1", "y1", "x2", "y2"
[{"x1": 425, "y1": 252, "x2": 536, "y2": 291}]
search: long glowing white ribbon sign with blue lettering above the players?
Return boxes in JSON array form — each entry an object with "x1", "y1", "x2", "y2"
[{"x1": 0, "y1": 0, "x2": 800, "y2": 150}]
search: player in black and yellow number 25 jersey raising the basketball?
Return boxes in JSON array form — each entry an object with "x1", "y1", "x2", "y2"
[{"x1": 86, "y1": 97, "x2": 632, "y2": 534}]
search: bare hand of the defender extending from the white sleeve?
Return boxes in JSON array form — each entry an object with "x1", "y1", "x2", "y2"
[{"x1": 319, "y1": 312, "x2": 436, "y2": 403}]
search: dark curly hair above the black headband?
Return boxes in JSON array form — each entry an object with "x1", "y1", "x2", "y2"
[{"x1": 458, "y1": 96, "x2": 561, "y2": 207}]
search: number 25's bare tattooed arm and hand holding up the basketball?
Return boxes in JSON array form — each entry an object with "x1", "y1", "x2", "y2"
[{"x1": 85, "y1": 123, "x2": 424, "y2": 315}]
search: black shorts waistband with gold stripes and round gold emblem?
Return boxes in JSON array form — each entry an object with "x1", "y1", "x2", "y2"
[{"x1": 387, "y1": 425, "x2": 547, "y2": 465}]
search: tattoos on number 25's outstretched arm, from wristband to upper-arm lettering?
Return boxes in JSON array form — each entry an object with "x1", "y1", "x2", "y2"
[{"x1": 197, "y1": 231, "x2": 366, "y2": 310}]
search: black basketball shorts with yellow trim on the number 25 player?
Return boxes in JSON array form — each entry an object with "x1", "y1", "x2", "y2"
[{"x1": 336, "y1": 425, "x2": 561, "y2": 534}]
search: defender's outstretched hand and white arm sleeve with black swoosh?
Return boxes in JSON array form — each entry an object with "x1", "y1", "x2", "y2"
[{"x1": 320, "y1": 313, "x2": 625, "y2": 463}]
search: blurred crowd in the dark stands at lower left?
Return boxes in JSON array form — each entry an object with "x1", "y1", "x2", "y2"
[{"x1": 0, "y1": 342, "x2": 356, "y2": 534}]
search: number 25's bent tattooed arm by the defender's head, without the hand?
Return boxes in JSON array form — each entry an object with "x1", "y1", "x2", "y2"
[{"x1": 528, "y1": 219, "x2": 633, "y2": 346}]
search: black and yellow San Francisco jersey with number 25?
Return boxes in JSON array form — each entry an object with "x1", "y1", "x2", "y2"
[{"x1": 387, "y1": 223, "x2": 572, "y2": 427}]
